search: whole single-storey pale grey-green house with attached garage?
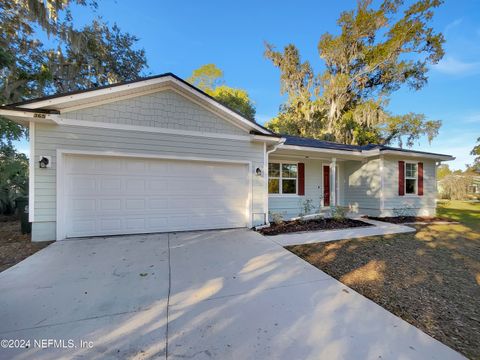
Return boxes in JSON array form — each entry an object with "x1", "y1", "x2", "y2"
[{"x1": 0, "y1": 74, "x2": 453, "y2": 241}]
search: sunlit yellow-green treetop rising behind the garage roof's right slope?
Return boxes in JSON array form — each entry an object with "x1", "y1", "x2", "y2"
[{"x1": 187, "y1": 64, "x2": 255, "y2": 120}]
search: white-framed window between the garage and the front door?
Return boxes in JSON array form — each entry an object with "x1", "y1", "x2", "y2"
[{"x1": 268, "y1": 163, "x2": 297, "y2": 194}]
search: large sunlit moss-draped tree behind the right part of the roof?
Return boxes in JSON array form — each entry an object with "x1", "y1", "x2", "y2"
[{"x1": 265, "y1": 0, "x2": 444, "y2": 146}]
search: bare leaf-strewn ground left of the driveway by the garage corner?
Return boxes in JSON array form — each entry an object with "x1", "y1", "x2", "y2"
[{"x1": 0, "y1": 216, "x2": 53, "y2": 272}]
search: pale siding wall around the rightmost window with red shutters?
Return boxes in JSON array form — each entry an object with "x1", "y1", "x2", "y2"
[{"x1": 381, "y1": 157, "x2": 437, "y2": 216}]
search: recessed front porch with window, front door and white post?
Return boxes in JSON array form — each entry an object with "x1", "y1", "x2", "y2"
[{"x1": 267, "y1": 146, "x2": 372, "y2": 219}]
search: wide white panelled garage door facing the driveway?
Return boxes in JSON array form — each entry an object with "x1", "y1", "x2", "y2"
[{"x1": 64, "y1": 155, "x2": 250, "y2": 237}]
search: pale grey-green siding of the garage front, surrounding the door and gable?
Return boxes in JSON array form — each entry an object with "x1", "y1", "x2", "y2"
[{"x1": 31, "y1": 92, "x2": 267, "y2": 241}]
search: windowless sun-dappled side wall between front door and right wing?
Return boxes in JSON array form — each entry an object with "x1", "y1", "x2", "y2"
[{"x1": 343, "y1": 158, "x2": 382, "y2": 216}]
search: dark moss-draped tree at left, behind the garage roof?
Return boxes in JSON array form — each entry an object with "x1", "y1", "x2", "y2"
[{"x1": 0, "y1": 0, "x2": 146, "y2": 148}]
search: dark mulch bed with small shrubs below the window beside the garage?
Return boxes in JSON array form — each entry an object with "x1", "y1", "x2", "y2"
[{"x1": 259, "y1": 218, "x2": 372, "y2": 235}]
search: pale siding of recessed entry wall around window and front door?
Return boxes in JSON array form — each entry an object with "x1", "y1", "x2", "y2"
[{"x1": 268, "y1": 156, "x2": 344, "y2": 219}]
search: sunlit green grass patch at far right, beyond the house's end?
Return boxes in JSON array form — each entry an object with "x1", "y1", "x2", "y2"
[{"x1": 437, "y1": 200, "x2": 480, "y2": 232}]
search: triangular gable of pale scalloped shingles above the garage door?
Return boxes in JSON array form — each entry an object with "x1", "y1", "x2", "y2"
[{"x1": 62, "y1": 90, "x2": 246, "y2": 135}]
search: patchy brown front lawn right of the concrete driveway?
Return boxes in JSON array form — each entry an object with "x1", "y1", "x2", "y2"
[{"x1": 287, "y1": 224, "x2": 480, "y2": 359}]
